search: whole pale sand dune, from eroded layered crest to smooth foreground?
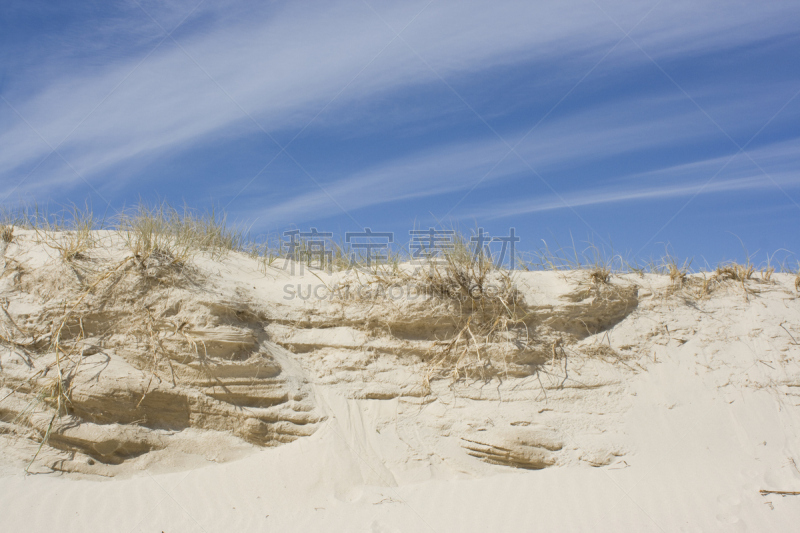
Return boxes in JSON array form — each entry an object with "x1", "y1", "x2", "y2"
[{"x1": 0, "y1": 231, "x2": 800, "y2": 533}]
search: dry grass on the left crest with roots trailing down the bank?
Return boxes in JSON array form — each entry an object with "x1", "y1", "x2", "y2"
[{"x1": 0, "y1": 200, "x2": 256, "y2": 467}]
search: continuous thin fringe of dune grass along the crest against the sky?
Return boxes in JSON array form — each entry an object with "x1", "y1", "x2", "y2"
[{"x1": 0, "y1": 202, "x2": 800, "y2": 317}]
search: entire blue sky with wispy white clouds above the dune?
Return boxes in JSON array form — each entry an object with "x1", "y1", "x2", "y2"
[{"x1": 0, "y1": 0, "x2": 800, "y2": 264}]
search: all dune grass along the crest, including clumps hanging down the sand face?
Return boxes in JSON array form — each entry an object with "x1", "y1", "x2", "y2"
[{"x1": 0, "y1": 203, "x2": 800, "y2": 470}]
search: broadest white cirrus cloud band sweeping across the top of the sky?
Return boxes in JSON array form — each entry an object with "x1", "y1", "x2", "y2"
[{"x1": 0, "y1": 0, "x2": 796, "y2": 193}]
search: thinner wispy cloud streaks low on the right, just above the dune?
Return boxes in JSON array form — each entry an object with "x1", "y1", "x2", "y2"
[{"x1": 245, "y1": 89, "x2": 800, "y2": 223}]
